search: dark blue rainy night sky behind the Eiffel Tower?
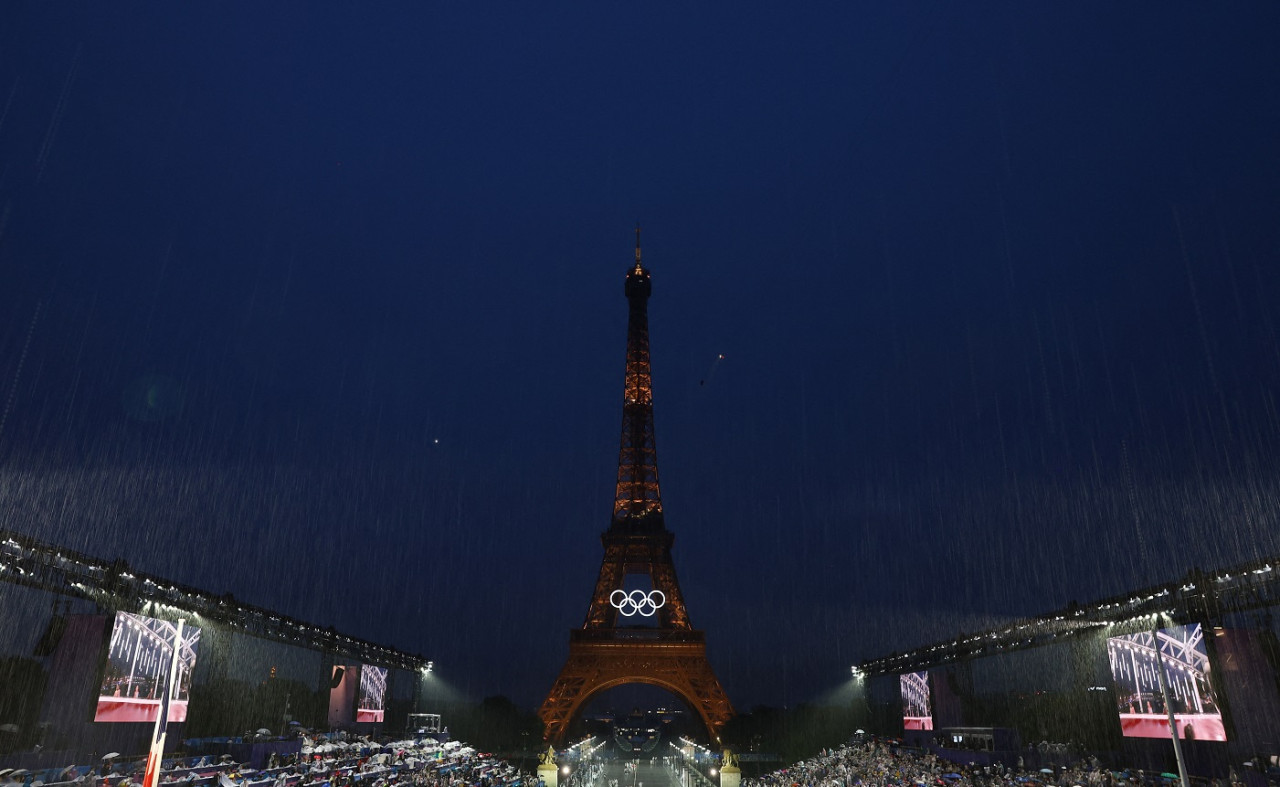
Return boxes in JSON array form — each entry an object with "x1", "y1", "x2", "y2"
[{"x1": 0, "y1": 0, "x2": 1280, "y2": 708}]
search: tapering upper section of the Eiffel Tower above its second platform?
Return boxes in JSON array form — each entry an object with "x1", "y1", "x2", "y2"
[{"x1": 611, "y1": 227, "x2": 664, "y2": 531}]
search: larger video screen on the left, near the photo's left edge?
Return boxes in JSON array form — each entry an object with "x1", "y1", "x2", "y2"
[{"x1": 93, "y1": 612, "x2": 200, "y2": 722}]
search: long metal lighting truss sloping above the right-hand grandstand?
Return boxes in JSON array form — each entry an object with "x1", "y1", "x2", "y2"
[{"x1": 852, "y1": 557, "x2": 1280, "y2": 677}]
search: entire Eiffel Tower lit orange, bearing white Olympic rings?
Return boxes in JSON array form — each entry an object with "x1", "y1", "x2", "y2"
[{"x1": 538, "y1": 228, "x2": 733, "y2": 743}]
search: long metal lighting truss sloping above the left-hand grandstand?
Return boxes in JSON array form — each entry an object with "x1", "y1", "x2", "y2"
[{"x1": 0, "y1": 530, "x2": 431, "y2": 669}]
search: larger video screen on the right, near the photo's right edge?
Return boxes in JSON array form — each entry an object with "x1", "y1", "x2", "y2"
[{"x1": 1107, "y1": 623, "x2": 1226, "y2": 741}]
